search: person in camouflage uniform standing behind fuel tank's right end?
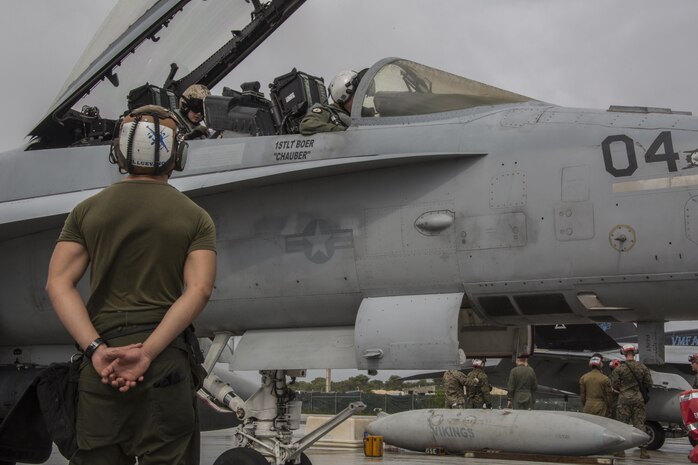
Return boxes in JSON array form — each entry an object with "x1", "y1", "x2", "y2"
[{"x1": 612, "y1": 345, "x2": 652, "y2": 458}]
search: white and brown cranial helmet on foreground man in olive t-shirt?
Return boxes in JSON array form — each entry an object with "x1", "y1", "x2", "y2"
[{"x1": 109, "y1": 105, "x2": 188, "y2": 175}]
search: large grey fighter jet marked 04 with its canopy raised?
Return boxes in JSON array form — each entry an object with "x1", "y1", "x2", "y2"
[{"x1": 0, "y1": 0, "x2": 698, "y2": 463}]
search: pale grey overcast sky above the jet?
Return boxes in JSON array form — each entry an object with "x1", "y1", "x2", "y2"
[{"x1": 0, "y1": 0, "x2": 698, "y2": 380}]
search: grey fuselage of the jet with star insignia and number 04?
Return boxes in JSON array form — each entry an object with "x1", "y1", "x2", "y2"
[{"x1": 0, "y1": 102, "x2": 698, "y2": 345}]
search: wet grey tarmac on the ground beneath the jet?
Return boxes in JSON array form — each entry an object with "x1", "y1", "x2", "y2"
[{"x1": 46, "y1": 430, "x2": 692, "y2": 465}]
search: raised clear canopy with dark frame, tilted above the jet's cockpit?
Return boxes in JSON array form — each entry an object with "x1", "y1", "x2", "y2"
[{"x1": 30, "y1": 0, "x2": 305, "y2": 146}]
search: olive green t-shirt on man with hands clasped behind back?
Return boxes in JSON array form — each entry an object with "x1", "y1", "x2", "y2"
[{"x1": 58, "y1": 181, "x2": 216, "y2": 332}]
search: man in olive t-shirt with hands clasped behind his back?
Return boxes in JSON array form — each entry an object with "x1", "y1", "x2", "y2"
[{"x1": 46, "y1": 106, "x2": 216, "y2": 465}]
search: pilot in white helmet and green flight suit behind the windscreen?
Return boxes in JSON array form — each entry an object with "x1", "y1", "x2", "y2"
[{"x1": 300, "y1": 69, "x2": 367, "y2": 136}]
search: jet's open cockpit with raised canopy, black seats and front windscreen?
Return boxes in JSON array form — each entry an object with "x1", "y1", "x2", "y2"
[{"x1": 29, "y1": 0, "x2": 531, "y2": 149}]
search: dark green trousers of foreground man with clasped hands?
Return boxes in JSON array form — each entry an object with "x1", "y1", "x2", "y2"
[{"x1": 70, "y1": 337, "x2": 200, "y2": 465}]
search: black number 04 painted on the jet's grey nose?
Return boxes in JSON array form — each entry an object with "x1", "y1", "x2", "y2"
[{"x1": 601, "y1": 131, "x2": 679, "y2": 178}]
